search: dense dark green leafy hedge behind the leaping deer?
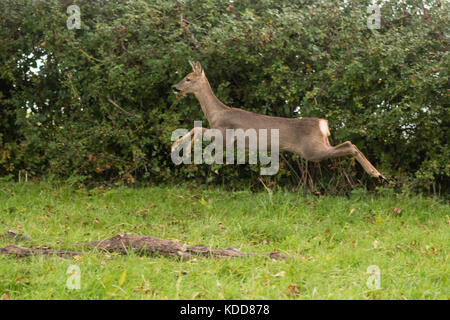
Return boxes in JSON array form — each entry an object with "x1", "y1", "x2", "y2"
[{"x1": 0, "y1": 0, "x2": 450, "y2": 192}]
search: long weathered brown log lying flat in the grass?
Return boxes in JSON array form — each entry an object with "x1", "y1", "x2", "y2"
[{"x1": 0, "y1": 234, "x2": 288, "y2": 259}]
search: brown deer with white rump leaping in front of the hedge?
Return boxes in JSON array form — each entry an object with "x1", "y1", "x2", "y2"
[{"x1": 172, "y1": 61, "x2": 389, "y2": 182}]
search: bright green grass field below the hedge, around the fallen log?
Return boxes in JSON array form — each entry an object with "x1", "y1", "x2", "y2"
[{"x1": 0, "y1": 182, "x2": 450, "y2": 299}]
